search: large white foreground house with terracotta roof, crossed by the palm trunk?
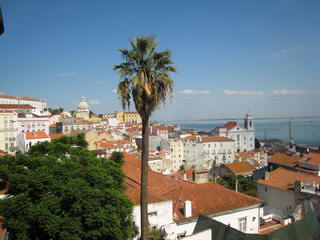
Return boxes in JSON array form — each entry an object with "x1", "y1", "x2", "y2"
[{"x1": 124, "y1": 154, "x2": 262, "y2": 239}]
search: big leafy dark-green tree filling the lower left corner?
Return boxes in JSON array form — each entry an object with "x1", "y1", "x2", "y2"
[{"x1": 0, "y1": 136, "x2": 135, "y2": 240}]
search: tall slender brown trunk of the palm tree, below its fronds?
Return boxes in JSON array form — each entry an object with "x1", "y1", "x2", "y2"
[{"x1": 140, "y1": 116, "x2": 149, "y2": 240}]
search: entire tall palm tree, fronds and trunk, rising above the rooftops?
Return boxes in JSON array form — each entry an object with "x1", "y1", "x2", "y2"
[{"x1": 113, "y1": 36, "x2": 176, "y2": 240}]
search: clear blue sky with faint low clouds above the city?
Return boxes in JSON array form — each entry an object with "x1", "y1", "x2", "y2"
[{"x1": 0, "y1": 0, "x2": 320, "y2": 120}]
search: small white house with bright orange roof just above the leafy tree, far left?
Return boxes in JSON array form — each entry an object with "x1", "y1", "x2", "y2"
[{"x1": 17, "y1": 131, "x2": 51, "y2": 153}]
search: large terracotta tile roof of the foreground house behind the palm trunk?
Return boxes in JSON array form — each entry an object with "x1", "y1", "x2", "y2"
[{"x1": 123, "y1": 153, "x2": 262, "y2": 221}]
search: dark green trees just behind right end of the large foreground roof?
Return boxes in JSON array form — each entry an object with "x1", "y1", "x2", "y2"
[{"x1": 217, "y1": 174, "x2": 257, "y2": 196}]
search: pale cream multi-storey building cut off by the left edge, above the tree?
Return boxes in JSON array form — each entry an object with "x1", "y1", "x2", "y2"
[{"x1": 0, "y1": 110, "x2": 18, "y2": 153}]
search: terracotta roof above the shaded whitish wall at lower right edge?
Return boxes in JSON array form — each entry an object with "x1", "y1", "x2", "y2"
[{"x1": 257, "y1": 168, "x2": 320, "y2": 191}]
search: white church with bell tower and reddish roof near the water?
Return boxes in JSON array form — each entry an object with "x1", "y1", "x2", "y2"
[{"x1": 212, "y1": 114, "x2": 255, "y2": 152}]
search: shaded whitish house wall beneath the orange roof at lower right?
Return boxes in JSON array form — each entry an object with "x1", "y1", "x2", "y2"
[{"x1": 257, "y1": 183, "x2": 296, "y2": 215}]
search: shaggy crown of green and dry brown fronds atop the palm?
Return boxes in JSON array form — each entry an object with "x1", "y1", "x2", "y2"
[{"x1": 113, "y1": 36, "x2": 176, "y2": 119}]
